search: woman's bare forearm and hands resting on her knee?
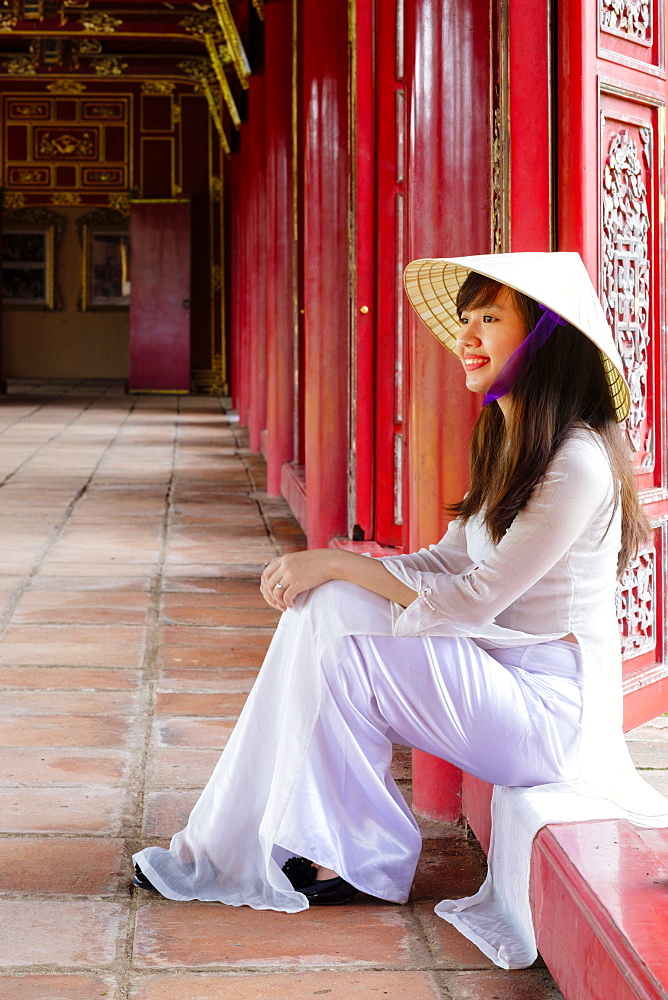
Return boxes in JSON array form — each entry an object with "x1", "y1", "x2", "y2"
[{"x1": 260, "y1": 549, "x2": 417, "y2": 611}]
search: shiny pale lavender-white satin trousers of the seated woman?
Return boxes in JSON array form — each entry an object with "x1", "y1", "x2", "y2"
[{"x1": 274, "y1": 636, "x2": 581, "y2": 902}]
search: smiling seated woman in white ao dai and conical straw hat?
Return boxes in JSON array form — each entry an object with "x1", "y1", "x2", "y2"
[{"x1": 135, "y1": 253, "x2": 668, "y2": 968}]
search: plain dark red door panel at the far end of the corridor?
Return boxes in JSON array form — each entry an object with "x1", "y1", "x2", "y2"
[{"x1": 128, "y1": 199, "x2": 191, "y2": 393}]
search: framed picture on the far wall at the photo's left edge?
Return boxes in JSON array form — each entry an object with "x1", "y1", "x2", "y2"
[{"x1": 2, "y1": 226, "x2": 55, "y2": 309}]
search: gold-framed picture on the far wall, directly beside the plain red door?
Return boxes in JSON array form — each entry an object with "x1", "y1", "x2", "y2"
[{"x1": 80, "y1": 209, "x2": 130, "y2": 311}]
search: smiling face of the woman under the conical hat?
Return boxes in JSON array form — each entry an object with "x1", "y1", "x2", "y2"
[{"x1": 457, "y1": 285, "x2": 528, "y2": 403}]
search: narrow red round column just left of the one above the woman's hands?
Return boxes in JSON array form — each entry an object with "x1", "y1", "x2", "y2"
[{"x1": 264, "y1": 0, "x2": 295, "y2": 496}]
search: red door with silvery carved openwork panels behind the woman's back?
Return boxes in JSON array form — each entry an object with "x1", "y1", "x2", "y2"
[{"x1": 557, "y1": 0, "x2": 668, "y2": 728}]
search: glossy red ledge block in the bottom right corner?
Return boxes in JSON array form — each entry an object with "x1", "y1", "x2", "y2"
[{"x1": 531, "y1": 820, "x2": 668, "y2": 1000}]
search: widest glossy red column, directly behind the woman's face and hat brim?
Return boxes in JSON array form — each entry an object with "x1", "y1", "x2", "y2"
[{"x1": 406, "y1": 0, "x2": 491, "y2": 819}]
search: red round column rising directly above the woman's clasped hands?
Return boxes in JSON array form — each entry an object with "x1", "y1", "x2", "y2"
[{"x1": 301, "y1": 0, "x2": 350, "y2": 548}]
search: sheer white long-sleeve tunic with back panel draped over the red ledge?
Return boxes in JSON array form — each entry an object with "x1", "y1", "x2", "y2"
[{"x1": 383, "y1": 428, "x2": 668, "y2": 968}]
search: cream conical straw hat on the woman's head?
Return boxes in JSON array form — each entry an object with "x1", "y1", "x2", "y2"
[{"x1": 404, "y1": 251, "x2": 631, "y2": 420}]
